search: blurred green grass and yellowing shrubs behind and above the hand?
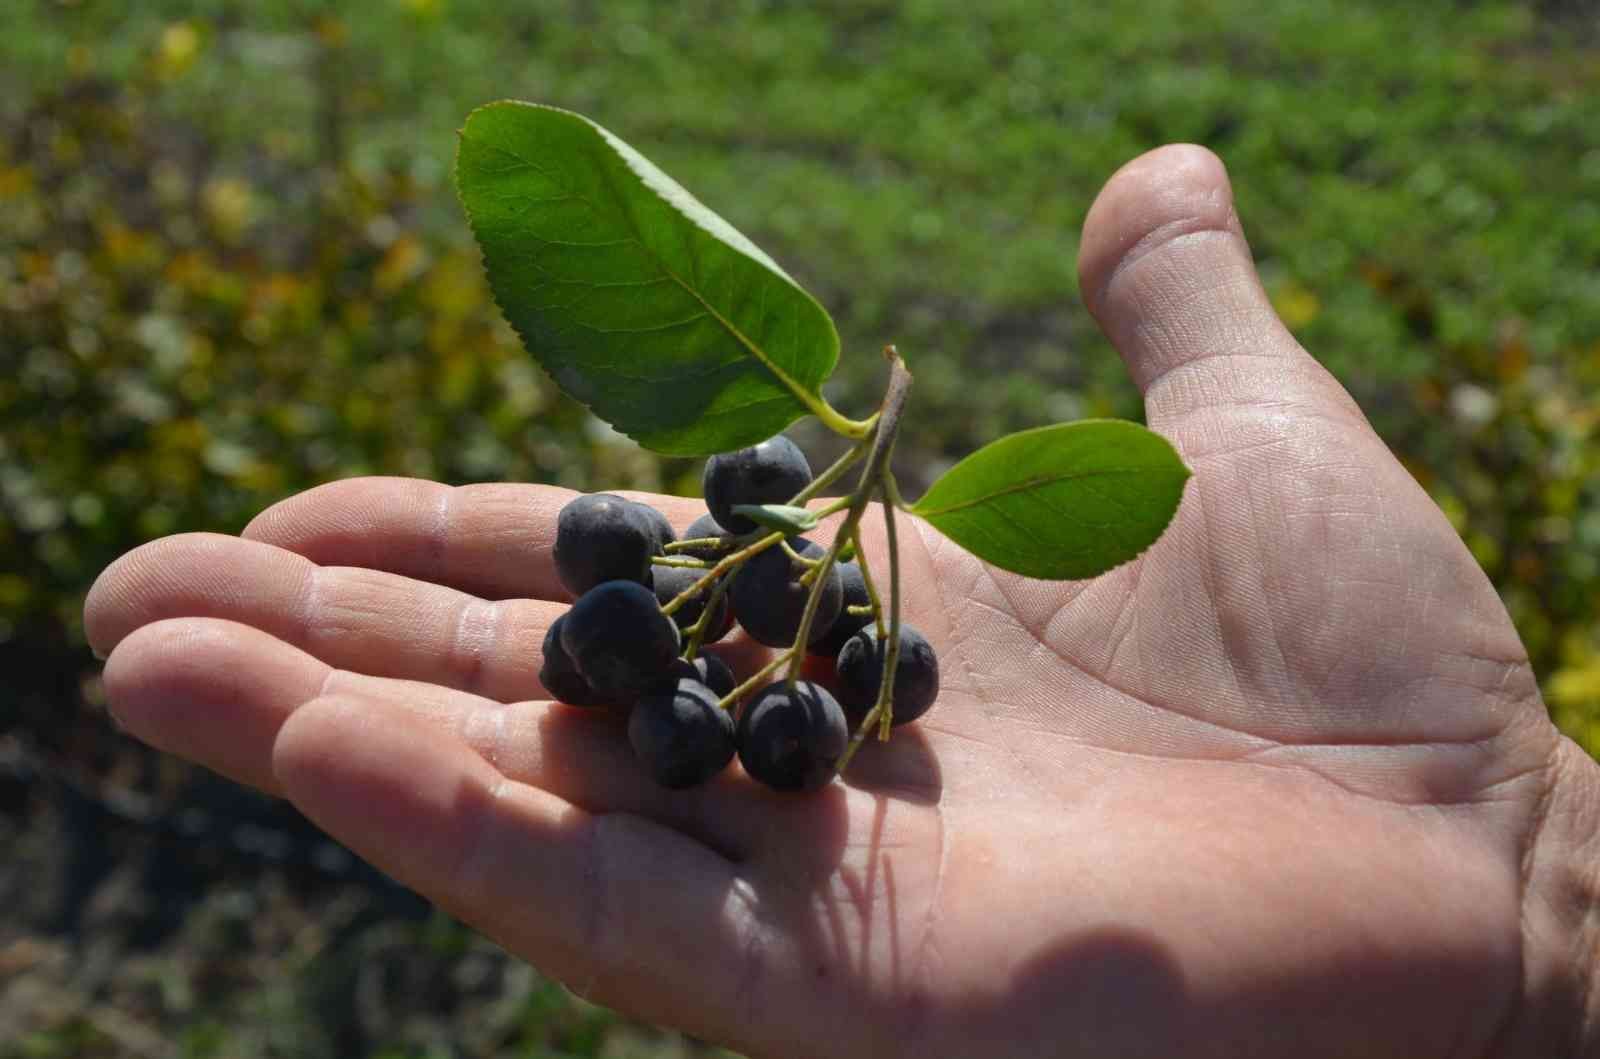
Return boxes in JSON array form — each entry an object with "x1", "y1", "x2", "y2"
[{"x1": 0, "y1": 0, "x2": 1600, "y2": 1054}]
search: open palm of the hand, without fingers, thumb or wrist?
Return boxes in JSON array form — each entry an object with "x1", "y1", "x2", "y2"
[{"x1": 704, "y1": 444, "x2": 1531, "y2": 1054}]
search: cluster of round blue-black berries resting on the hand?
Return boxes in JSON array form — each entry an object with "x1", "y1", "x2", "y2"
[{"x1": 539, "y1": 435, "x2": 939, "y2": 790}]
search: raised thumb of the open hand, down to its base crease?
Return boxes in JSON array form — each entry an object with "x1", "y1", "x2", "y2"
[{"x1": 1078, "y1": 144, "x2": 1366, "y2": 432}]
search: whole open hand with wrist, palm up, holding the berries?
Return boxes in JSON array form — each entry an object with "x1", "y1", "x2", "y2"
[{"x1": 86, "y1": 146, "x2": 1600, "y2": 1059}]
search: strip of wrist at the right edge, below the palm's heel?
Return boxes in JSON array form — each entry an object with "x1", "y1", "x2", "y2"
[{"x1": 1494, "y1": 729, "x2": 1600, "y2": 1059}]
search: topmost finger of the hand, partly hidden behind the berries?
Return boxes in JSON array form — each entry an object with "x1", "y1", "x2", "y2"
[{"x1": 242, "y1": 477, "x2": 706, "y2": 600}]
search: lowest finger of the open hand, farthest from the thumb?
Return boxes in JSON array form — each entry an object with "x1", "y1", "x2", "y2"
[{"x1": 272, "y1": 696, "x2": 784, "y2": 1038}]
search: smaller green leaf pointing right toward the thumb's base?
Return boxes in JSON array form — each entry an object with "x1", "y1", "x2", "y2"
[{"x1": 910, "y1": 419, "x2": 1189, "y2": 581}]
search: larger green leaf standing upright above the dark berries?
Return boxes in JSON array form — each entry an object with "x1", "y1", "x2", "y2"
[{"x1": 456, "y1": 101, "x2": 866, "y2": 456}]
